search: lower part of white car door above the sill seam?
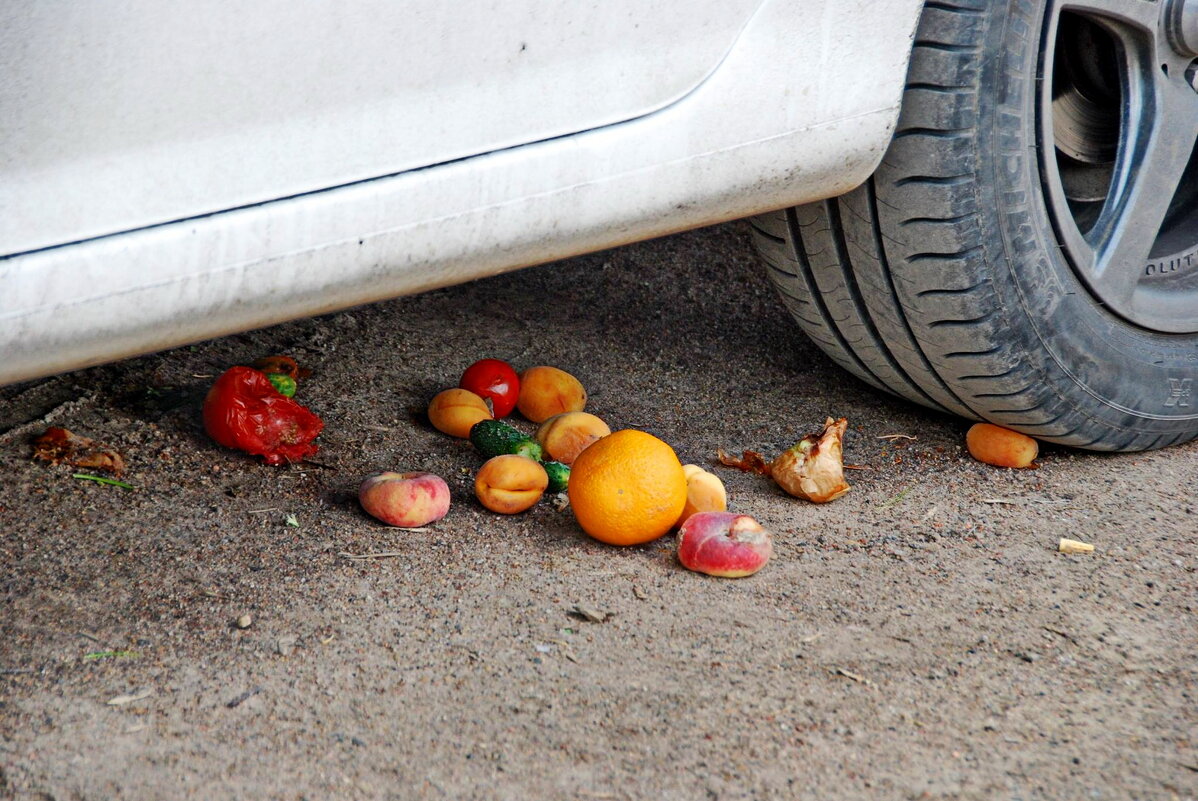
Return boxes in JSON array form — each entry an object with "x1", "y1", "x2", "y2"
[{"x1": 0, "y1": 0, "x2": 761, "y2": 254}]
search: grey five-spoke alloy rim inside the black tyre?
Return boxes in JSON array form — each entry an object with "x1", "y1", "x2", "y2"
[{"x1": 1037, "y1": 0, "x2": 1198, "y2": 334}]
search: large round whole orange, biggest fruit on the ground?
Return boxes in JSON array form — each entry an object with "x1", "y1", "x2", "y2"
[{"x1": 567, "y1": 429, "x2": 686, "y2": 545}]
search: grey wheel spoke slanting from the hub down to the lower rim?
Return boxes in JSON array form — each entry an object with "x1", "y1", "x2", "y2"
[{"x1": 1085, "y1": 59, "x2": 1198, "y2": 303}]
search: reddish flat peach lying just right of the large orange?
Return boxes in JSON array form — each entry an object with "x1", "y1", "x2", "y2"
[{"x1": 678, "y1": 511, "x2": 774, "y2": 578}]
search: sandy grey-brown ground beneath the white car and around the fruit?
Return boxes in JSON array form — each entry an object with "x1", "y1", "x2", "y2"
[{"x1": 0, "y1": 224, "x2": 1198, "y2": 801}]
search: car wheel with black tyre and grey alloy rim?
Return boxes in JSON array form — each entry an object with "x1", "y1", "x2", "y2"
[{"x1": 751, "y1": 0, "x2": 1198, "y2": 450}]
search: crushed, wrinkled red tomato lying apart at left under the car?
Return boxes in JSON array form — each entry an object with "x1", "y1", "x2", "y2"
[{"x1": 204, "y1": 368, "x2": 325, "y2": 465}]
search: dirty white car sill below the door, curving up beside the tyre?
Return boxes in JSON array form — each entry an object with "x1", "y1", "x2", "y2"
[{"x1": 0, "y1": 0, "x2": 921, "y2": 382}]
